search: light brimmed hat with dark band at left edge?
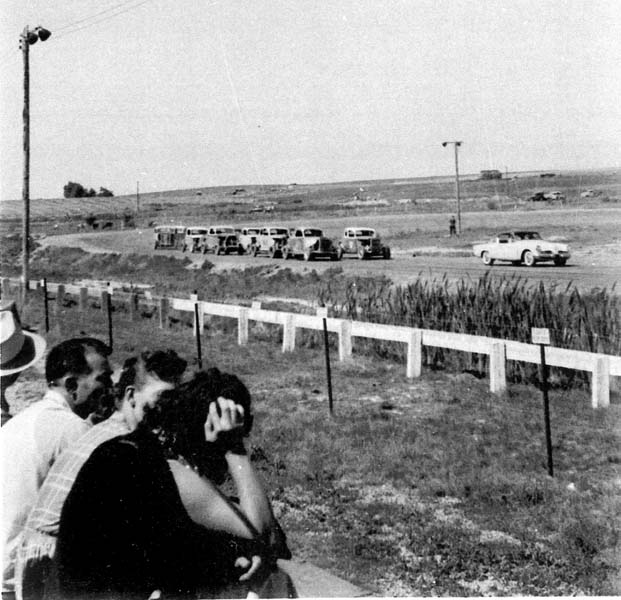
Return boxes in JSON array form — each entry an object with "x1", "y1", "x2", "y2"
[{"x1": 0, "y1": 301, "x2": 46, "y2": 376}]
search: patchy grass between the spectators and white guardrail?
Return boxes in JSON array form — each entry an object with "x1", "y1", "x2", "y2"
[{"x1": 9, "y1": 298, "x2": 621, "y2": 596}]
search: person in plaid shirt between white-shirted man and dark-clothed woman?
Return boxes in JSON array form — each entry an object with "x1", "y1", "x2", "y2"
[{"x1": 15, "y1": 350, "x2": 187, "y2": 600}]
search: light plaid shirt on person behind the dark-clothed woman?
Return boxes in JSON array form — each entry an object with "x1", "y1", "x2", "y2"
[{"x1": 18, "y1": 412, "x2": 129, "y2": 563}]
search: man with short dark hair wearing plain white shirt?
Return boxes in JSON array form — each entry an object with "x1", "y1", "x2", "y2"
[{"x1": 0, "y1": 338, "x2": 112, "y2": 596}]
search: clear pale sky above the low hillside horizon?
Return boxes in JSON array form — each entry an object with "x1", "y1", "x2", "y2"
[{"x1": 0, "y1": 0, "x2": 621, "y2": 199}]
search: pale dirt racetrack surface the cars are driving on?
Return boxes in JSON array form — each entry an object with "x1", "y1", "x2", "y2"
[{"x1": 43, "y1": 230, "x2": 621, "y2": 290}]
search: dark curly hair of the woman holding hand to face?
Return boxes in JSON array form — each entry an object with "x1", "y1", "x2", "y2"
[{"x1": 140, "y1": 368, "x2": 253, "y2": 483}]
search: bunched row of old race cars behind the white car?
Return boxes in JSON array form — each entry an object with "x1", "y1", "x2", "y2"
[{"x1": 154, "y1": 225, "x2": 390, "y2": 261}]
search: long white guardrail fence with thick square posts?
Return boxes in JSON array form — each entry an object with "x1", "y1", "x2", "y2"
[{"x1": 2, "y1": 278, "x2": 621, "y2": 408}]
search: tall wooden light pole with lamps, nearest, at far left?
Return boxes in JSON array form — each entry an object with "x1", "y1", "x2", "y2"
[{"x1": 19, "y1": 25, "x2": 52, "y2": 294}]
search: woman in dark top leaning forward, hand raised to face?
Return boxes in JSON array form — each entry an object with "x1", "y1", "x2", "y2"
[{"x1": 56, "y1": 369, "x2": 295, "y2": 598}]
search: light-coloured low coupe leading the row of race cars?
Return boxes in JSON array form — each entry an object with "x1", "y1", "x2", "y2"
[{"x1": 472, "y1": 231, "x2": 570, "y2": 267}]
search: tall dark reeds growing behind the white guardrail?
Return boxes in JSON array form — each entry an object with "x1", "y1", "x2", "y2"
[{"x1": 318, "y1": 274, "x2": 621, "y2": 385}]
